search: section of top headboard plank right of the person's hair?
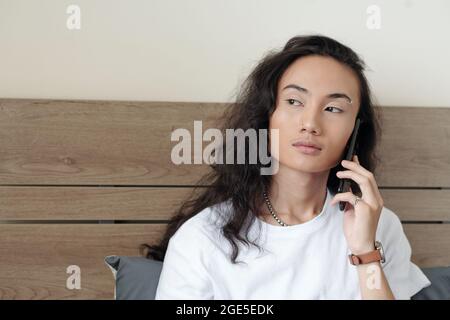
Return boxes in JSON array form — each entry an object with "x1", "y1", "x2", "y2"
[{"x1": 375, "y1": 107, "x2": 450, "y2": 188}]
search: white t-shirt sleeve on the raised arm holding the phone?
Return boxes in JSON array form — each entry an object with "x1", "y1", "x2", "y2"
[{"x1": 377, "y1": 207, "x2": 431, "y2": 300}]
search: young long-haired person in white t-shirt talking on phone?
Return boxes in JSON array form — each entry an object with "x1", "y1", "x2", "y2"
[{"x1": 145, "y1": 35, "x2": 431, "y2": 299}]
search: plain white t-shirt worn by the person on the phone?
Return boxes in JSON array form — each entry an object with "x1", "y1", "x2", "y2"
[{"x1": 155, "y1": 189, "x2": 431, "y2": 300}]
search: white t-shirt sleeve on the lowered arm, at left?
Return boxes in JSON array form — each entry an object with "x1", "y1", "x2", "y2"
[{"x1": 155, "y1": 220, "x2": 214, "y2": 300}]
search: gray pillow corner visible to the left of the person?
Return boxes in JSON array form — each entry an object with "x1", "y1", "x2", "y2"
[{"x1": 105, "y1": 256, "x2": 163, "y2": 300}]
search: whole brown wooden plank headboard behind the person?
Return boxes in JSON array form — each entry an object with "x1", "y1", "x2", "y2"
[{"x1": 0, "y1": 99, "x2": 450, "y2": 299}]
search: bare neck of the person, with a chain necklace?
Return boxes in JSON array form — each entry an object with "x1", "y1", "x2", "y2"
[{"x1": 263, "y1": 166, "x2": 329, "y2": 225}]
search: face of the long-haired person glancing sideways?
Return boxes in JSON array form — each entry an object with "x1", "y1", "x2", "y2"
[{"x1": 269, "y1": 55, "x2": 360, "y2": 173}]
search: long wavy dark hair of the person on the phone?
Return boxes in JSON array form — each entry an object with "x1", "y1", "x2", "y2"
[{"x1": 141, "y1": 34, "x2": 382, "y2": 264}]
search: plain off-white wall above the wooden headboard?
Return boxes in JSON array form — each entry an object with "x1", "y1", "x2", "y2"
[{"x1": 0, "y1": 0, "x2": 450, "y2": 107}]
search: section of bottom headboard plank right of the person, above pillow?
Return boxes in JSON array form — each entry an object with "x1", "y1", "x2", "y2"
[{"x1": 403, "y1": 223, "x2": 450, "y2": 268}]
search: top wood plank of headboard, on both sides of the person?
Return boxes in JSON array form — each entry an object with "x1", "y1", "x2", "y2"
[{"x1": 0, "y1": 99, "x2": 450, "y2": 188}]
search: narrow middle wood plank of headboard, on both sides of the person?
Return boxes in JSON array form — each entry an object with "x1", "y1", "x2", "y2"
[{"x1": 0, "y1": 186, "x2": 450, "y2": 221}]
